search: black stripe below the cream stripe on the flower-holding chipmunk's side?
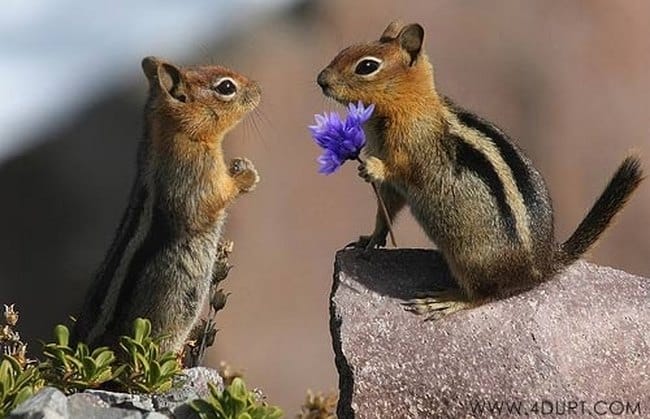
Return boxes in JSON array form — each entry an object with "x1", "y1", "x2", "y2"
[{"x1": 450, "y1": 135, "x2": 519, "y2": 241}]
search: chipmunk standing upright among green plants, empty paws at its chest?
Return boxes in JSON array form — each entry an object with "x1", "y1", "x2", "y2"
[{"x1": 73, "y1": 57, "x2": 261, "y2": 351}]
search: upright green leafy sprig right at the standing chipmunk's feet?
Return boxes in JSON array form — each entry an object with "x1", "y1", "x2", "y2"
[{"x1": 116, "y1": 318, "x2": 181, "y2": 393}]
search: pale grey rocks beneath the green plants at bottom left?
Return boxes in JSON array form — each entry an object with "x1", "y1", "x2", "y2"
[{"x1": 9, "y1": 367, "x2": 223, "y2": 419}]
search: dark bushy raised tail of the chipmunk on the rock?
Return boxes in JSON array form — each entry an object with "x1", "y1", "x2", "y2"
[{"x1": 558, "y1": 156, "x2": 643, "y2": 265}]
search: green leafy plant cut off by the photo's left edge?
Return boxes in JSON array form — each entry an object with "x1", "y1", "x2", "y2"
[{"x1": 0, "y1": 355, "x2": 44, "y2": 417}]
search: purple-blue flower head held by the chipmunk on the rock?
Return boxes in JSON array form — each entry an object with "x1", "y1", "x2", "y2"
[{"x1": 309, "y1": 102, "x2": 375, "y2": 175}]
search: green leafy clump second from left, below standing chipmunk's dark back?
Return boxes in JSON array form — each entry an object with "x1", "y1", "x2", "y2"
[{"x1": 40, "y1": 324, "x2": 125, "y2": 394}]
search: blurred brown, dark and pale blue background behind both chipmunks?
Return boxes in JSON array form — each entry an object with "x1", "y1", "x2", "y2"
[{"x1": 0, "y1": 0, "x2": 650, "y2": 416}]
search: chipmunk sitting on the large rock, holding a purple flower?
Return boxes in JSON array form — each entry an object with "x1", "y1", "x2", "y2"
[{"x1": 317, "y1": 21, "x2": 642, "y2": 319}]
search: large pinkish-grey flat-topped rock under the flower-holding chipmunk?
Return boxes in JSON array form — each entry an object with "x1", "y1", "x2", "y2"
[{"x1": 330, "y1": 250, "x2": 650, "y2": 418}]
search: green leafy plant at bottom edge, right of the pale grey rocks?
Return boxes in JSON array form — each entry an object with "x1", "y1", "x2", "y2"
[{"x1": 190, "y1": 377, "x2": 282, "y2": 419}]
